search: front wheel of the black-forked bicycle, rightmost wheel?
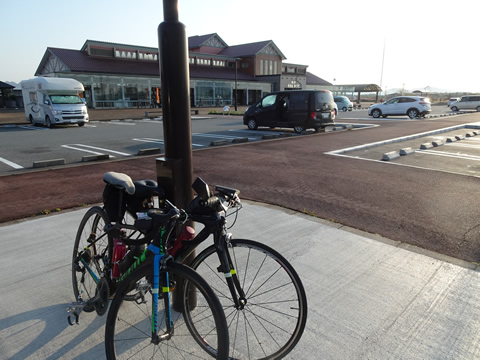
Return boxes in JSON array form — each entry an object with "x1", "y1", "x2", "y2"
[{"x1": 191, "y1": 239, "x2": 307, "y2": 359}]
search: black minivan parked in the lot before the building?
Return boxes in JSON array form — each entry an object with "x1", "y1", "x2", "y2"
[{"x1": 243, "y1": 90, "x2": 335, "y2": 133}]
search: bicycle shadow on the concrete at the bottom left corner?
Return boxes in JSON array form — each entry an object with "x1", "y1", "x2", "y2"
[{"x1": 0, "y1": 304, "x2": 106, "y2": 360}]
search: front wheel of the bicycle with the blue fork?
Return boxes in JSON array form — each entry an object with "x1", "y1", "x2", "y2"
[{"x1": 105, "y1": 261, "x2": 229, "y2": 359}]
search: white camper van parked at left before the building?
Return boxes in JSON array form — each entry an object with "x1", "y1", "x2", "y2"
[{"x1": 20, "y1": 77, "x2": 88, "y2": 128}]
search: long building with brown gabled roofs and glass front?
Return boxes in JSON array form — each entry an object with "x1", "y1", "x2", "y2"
[{"x1": 31, "y1": 34, "x2": 332, "y2": 108}]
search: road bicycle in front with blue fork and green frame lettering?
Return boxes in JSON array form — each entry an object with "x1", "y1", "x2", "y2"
[{"x1": 69, "y1": 176, "x2": 229, "y2": 359}]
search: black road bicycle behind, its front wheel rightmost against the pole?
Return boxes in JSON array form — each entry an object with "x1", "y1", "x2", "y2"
[{"x1": 70, "y1": 173, "x2": 307, "y2": 359}]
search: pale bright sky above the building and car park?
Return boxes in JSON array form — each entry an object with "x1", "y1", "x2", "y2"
[{"x1": 0, "y1": 0, "x2": 480, "y2": 93}]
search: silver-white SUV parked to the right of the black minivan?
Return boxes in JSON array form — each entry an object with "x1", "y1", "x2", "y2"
[{"x1": 368, "y1": 96, "x2": 432, "y2": 119}]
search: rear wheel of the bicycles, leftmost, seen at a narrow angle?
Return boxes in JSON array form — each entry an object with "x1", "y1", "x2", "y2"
[{"x1": 72, "y1": 206, "x2": 110, "y2": 312}]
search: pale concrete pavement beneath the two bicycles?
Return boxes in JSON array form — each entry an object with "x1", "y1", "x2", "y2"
[{"x1": 0, "y1": 202, "x2": 480, "y2": 360}]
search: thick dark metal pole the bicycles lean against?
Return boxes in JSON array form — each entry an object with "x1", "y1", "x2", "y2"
[{"x1": 157, "y1": 0, "x2": 195, "y2": 311}]
